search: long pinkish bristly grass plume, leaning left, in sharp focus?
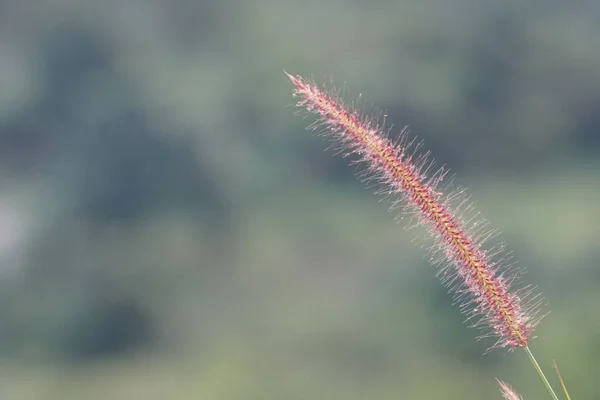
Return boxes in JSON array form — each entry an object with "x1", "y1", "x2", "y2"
[{"x1": 286, "y1": 72, "x2": 540, "y2": 349}]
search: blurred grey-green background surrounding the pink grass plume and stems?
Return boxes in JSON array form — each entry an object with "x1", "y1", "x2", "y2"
[{"x1": 0, "y1": 0, "x2": 600, "y2": 400}]
